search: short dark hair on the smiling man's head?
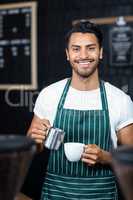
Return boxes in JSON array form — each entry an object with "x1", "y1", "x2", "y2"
[{"x1": 65, "y1": 20, "x2": 103, "y2": 48}]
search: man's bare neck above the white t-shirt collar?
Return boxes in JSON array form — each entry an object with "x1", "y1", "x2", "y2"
[{"x1": 71, "y1": 71, "x2": 99, "y2": 91}]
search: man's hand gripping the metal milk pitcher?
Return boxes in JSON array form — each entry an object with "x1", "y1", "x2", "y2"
[{"x1": 27, "y1": 116, "x2": 51, "y2": 149}]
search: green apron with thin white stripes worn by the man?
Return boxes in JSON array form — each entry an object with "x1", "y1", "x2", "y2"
[{"x1": 41, "y1": 79, "x2": 118, "y2": 200}]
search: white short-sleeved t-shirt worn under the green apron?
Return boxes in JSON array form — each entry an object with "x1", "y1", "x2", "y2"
[{"x1": 34, "y1": 79, "x2": 133, "y2": 147}]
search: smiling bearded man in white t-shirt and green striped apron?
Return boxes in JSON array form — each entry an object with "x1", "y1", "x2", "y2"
[{"x1": 28, "y1": 21, "x2": 133, "y2": 200}]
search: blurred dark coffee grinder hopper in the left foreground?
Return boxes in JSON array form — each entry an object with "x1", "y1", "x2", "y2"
[{"x1": 0, "y1": 135, "x2": 36, "y2": 200}]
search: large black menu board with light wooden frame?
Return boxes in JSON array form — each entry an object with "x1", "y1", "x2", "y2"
[{"x1": 0, "y1": 2, "x2": 37, "y2": 90}]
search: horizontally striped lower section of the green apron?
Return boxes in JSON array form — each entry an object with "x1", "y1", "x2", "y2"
[{"x1": 42, "y1": 173, "x2": 117, "y2": 200}]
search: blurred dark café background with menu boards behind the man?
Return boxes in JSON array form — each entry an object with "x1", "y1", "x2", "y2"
[{"x1": 0, "y1": 0, "x2": 133, "y2": 199}]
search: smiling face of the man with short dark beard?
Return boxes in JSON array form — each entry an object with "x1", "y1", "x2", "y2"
[{"x1": 66, "y1": 32, "x2": 102, "y2": 78}]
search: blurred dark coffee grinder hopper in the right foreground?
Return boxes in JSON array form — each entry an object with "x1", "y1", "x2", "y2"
[{"x1": 112, "y1": 145, "x2": 133, "y2": 200}]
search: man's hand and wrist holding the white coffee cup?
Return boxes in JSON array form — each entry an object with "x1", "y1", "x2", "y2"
[{"x1": 81, "y1": 144, "x2": 112, "y2": 166}]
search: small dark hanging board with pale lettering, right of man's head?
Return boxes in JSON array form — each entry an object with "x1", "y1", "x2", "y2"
[{"x1": 109, "y1": 16, "x2": 133, "y2": 67}]
